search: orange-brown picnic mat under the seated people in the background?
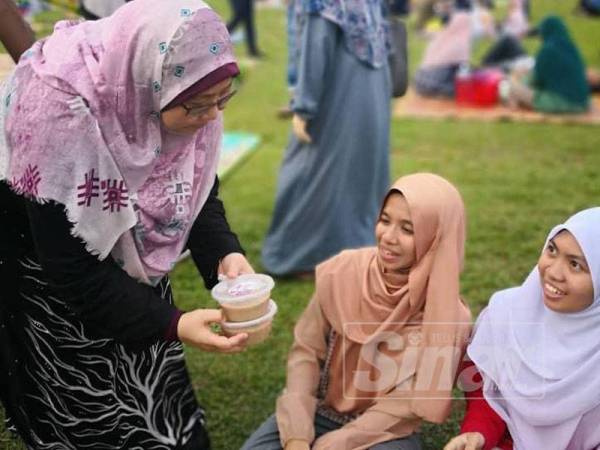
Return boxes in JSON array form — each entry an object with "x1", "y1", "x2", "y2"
[{"x1": 393, "y1": 89, "x2": 600, "y2": 125}]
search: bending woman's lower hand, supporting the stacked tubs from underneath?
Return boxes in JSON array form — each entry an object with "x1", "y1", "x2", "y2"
[{"x1": 177, "y1": 309, "x2": 248, "y2": 353}]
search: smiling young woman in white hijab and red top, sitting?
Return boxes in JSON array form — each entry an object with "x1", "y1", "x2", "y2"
[{"x1": 444, "y1": 208, "x2": 600, "y2": 450}]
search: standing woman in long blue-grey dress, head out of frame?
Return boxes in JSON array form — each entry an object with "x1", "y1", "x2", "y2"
[{"x1": 262, "y1": 0, "x2": 392, "y2": 275}]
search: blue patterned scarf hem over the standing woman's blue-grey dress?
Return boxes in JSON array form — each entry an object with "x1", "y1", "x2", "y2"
[{"x1": 293, "y1": 0, "x2": 390, "y2": 68}]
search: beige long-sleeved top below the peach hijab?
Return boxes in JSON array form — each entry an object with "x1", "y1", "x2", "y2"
[{"x1": 276, "y1": 299, "x2": 421, "y2": 450}]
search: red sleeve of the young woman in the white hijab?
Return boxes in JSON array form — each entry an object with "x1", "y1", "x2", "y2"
[{"x1": 459, "y1": 361, "x2": 506, "y2": 450}]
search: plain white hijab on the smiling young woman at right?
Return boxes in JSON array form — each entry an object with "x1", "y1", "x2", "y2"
[{"x1": 467, "y1": 208, "x2": 600, "y2": 450}]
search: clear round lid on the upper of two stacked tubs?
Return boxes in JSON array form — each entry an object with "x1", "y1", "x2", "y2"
[{"x1": 211, "y1": 273, "x2": 275, "y2": 305}]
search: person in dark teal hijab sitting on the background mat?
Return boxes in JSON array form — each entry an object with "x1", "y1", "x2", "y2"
[{"x1": 508, "y1": 16, "x2": 590, "y2": 113}]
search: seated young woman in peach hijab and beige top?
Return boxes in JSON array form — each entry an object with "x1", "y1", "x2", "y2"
[{"x1": 242, "y1": 173, "x2": 471, "y2": 450}]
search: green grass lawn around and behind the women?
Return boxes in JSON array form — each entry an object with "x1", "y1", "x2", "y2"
[{"x1": 0, "y1": 0, "x2": 600, "y2": 450}]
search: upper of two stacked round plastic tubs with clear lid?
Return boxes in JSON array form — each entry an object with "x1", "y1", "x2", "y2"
[{"x1": 211, "y1": 273, "x2": 275, "y2": 322}]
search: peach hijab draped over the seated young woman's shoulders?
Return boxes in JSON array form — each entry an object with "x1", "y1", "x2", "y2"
[{"x1": 316, "y1": 173, "x2": 471, "y2": 422}]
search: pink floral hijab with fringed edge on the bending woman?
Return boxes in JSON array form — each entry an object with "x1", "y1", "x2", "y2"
[{"x1": 0, "y1": 0, "x2": 235, "y2": 284}]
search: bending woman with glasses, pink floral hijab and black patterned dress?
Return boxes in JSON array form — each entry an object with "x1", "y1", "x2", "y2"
[{"x1": 0, "y1": 0, "x2": 252, "y2": 449}]
